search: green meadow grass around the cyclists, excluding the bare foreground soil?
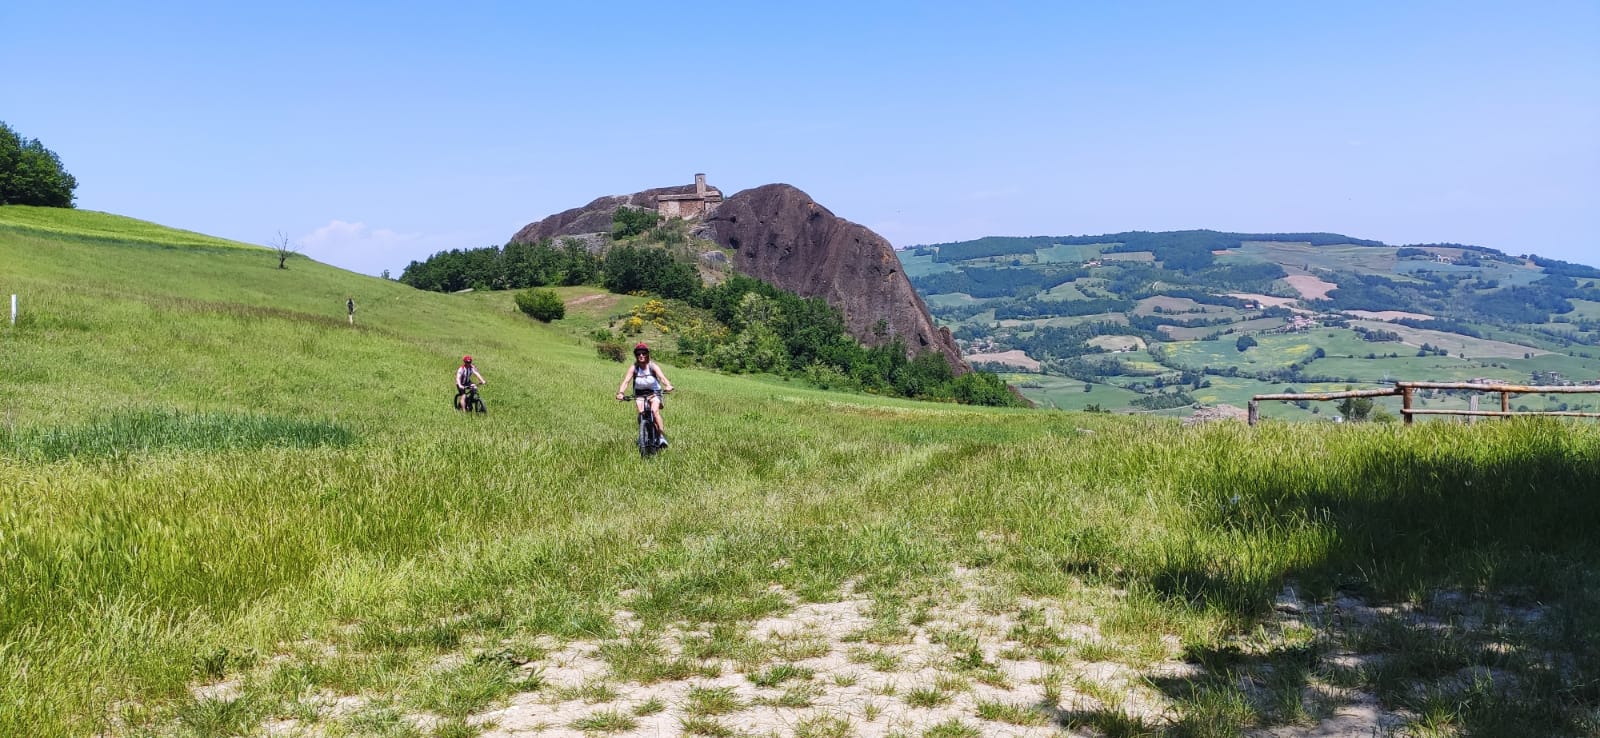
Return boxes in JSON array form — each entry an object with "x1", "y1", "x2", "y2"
[{"x1": 9, "y1": 208, "x2": 1600, "y2": 736}]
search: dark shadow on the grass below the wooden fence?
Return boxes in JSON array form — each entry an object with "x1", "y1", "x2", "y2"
[{"x1": 1136, "y1": 423, "x2": 1600, "y2": 736}]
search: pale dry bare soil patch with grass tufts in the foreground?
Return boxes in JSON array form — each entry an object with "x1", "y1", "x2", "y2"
[{"x1": 240, "y1": 568, "x2": 1574, "y2": 738}]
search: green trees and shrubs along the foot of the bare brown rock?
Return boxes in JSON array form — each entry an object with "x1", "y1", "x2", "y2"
[{"x1": 678, "y1": 275, "x2": 1024, "y2": 407}]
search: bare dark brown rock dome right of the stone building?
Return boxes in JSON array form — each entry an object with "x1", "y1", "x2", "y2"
[{"x1": 706, "y1": 184, "x2": 971, "y2": 375}]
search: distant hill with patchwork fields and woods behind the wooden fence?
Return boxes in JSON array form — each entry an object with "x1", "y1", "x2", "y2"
[{"x1": 899, "y1": 231, "x2": 1600, "y2": 418}]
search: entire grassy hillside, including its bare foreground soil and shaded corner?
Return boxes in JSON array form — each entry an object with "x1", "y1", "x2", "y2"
[{"x1": 9, "y1": 207, "x2": 1600, "y2": 736}]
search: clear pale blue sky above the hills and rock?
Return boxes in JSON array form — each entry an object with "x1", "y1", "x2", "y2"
[{"x1": 0, "y1": 0, "x2": 1600, "y2": 275}]
